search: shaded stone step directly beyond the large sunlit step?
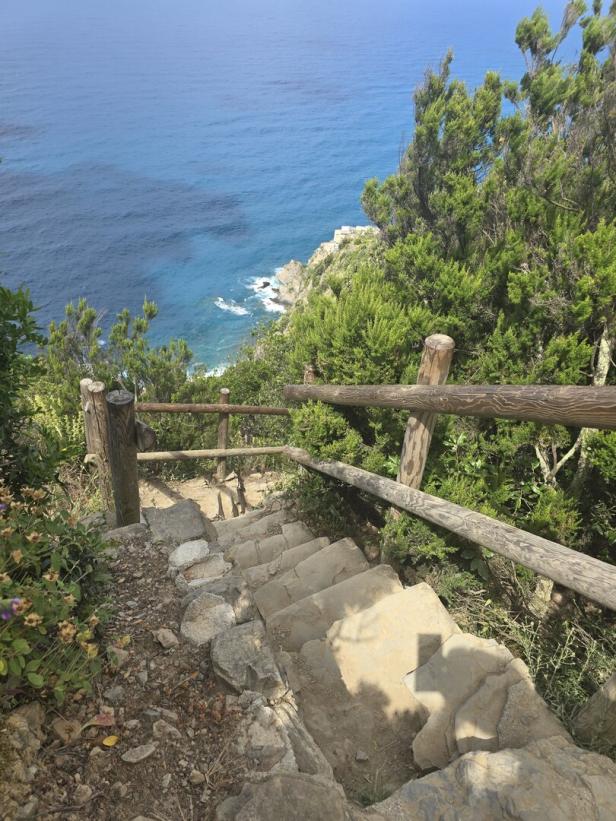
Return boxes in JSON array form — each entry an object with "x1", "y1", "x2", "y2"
[{"x1": 266, "y1": 564, "x2": 402, "y2": 651}]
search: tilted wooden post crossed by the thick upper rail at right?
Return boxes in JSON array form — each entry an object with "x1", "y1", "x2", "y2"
[{"x1": 398, "y1": 334, "x2": 455, "y2": 488}]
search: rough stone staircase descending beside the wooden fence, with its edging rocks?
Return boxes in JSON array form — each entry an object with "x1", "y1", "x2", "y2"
[{"x1": 145, "y1": 500, "x2": 616, "y2": 821}]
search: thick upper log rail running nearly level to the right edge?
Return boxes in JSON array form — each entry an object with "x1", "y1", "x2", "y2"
[{"x1": 284, "y1": 385, "x2": 616, "y2": 430}]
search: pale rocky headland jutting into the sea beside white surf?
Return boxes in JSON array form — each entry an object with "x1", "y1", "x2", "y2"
[{"x1": 253, "y1": 225, "x2": 379, "y2": 311}]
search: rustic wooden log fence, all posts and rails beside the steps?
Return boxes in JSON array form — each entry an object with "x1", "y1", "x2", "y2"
[{"x1": 81, "y1": 334, "x2": 616, "y2": 610}]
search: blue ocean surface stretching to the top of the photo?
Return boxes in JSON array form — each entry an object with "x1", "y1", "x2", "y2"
[{"x1": 0, "y1": 0, "x2": 564, "y2": 368}]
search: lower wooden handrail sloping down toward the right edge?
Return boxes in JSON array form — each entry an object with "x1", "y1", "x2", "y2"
[{"x1": 285, "y1": 447, "x2": 616, "y2": 610}]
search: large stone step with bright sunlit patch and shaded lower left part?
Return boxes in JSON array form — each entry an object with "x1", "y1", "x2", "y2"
[{"x1": 272, "y1": 583, "x2": 460, "y2": 795}]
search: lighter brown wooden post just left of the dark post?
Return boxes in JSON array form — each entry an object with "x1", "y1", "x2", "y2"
[{"x1": 79, "y1": 379, "x2": 113, "y2": 510}]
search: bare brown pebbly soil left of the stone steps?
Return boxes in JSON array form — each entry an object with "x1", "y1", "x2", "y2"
[{"x1": 22, "y1": 537, "x2": 251, "y2": 821}]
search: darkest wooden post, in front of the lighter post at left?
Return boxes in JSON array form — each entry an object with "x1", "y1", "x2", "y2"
[{"x1": 107, "y1": 390, "x2": 139, "y2": 527}]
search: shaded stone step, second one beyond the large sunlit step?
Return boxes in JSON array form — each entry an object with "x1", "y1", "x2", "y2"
[{"x1": 254, "y1": 539, "x2": 368, "y2": 619}]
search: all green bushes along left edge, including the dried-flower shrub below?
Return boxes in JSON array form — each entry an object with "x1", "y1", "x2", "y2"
[{"x1": 0, "y1": 288, "x2": 108, "y2": 706}]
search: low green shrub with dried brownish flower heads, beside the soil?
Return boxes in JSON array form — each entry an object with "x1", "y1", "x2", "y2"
[{"x1": 0, "y1": 486, "x2": 104, "y2": 702}]
